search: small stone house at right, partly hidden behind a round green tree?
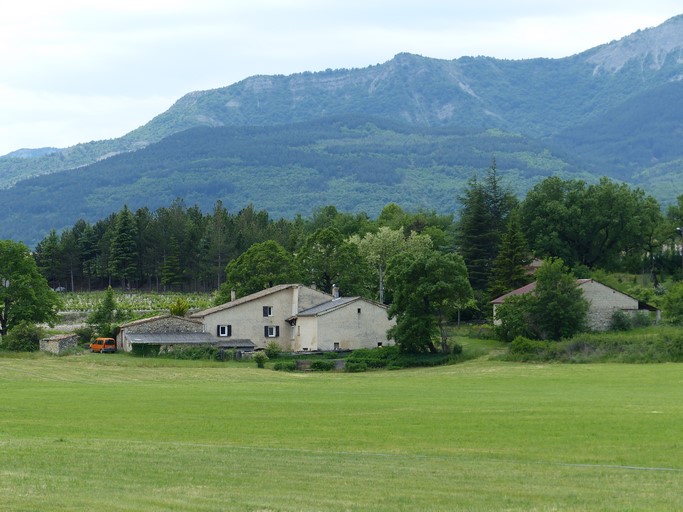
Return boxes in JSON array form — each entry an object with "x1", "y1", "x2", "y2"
[{"x1": 491, "y1": 279, "x2": 660, "y2": 331}]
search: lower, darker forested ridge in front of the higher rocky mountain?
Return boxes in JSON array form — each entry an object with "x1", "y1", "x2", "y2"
[{"x1": 0, "y1": 116, "x2": 591, "y2": 244}]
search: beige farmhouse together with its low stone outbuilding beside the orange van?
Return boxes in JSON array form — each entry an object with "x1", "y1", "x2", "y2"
[{"x1": 117, "y1": 284, "x2": 394, "y2": 352}]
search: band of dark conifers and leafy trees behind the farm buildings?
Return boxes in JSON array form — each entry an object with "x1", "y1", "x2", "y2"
[{"x1": 29, "y1": 169, "x2": 683, "y2": 309}]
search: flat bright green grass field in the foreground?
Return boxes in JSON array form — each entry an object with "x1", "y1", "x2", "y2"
[{"x1": 0, "y1": 354, "x2": 683, "y2": 511}]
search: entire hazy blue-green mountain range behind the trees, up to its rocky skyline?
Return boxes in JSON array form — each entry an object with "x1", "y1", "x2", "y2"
[{"x1": 0, "y1": 12, "x2": 683, "y2": 241}]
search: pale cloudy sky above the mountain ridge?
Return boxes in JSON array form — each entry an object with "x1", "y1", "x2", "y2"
[{"x1": 0, "y1": 0, "x2": 683, "y2": 155}]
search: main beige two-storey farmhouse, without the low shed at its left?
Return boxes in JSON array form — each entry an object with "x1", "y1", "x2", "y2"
[{"x1": 190, "y1": 284, "x2": 393, "y2": 351}]
